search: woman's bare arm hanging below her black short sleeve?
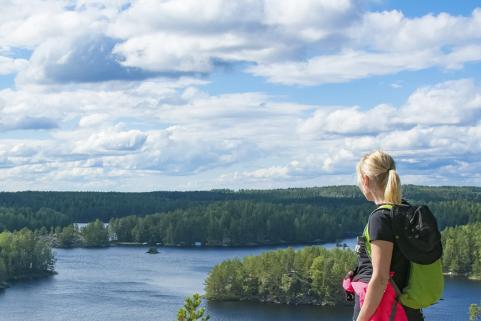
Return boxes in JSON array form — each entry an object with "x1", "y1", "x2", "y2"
[{"x1": 357, "y1": 240, "x2": 393, "y2": 321}]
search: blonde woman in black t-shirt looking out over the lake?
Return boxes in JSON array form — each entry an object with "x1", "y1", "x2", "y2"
[{"x1": 351, "y1": 151, "x2": 424, "y2": 321}]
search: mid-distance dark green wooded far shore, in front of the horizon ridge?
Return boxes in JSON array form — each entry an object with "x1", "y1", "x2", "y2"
[{"x1": 109, "y1": 201, "x2": 371, "y2": 246}]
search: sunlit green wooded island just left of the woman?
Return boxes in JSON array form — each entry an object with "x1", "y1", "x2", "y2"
[{"x1": 205, "y1": 246, "x2": 356, "y2": 306}]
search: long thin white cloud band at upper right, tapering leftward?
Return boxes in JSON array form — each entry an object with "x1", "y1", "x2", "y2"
[{"x1": 247, "y1": 46, "x2": 481, "y2": 85}]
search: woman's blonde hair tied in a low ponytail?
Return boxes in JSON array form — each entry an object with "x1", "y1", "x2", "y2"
[{"x1": 356, "y1": 150, "x2": 401, "y2": 204}]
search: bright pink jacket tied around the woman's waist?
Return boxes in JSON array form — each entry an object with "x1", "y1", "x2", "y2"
[{"x1": 342, "y1": 273, "x2": 408, "y2": 321}]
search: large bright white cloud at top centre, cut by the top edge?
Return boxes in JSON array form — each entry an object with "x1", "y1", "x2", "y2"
[{"x1": 108, "y1": 0, "x2": 358, "y2": 76}]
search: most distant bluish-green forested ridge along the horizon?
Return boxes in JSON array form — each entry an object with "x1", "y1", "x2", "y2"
[{"x1": 0, "y1": 185, "x2": 481, "y2": 223}]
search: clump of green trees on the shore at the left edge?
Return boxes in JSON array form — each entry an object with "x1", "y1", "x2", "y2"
[{"x1": 0, "y1": 229, "x2": 55, "y2": 288}]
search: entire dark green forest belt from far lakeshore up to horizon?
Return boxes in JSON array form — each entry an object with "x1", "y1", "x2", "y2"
[{"x1": 0, "y1": 185, "x2": 481, "y2": 246}]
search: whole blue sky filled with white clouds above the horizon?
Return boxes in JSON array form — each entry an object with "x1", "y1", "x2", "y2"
[{"x1": 0, "y1": 0, "x2": 481, "y2": 192}]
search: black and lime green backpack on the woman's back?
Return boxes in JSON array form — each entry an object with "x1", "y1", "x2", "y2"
[{"x1": 364, "y1": 204, "x2": 444, "y2": 309}]
